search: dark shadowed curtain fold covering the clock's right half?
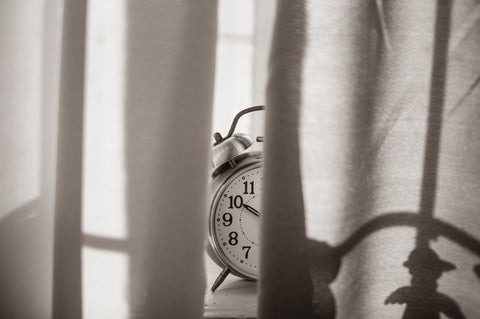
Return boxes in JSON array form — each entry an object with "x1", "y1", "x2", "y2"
[{"x1": 258, "y1": 1, "x2": 312, "y2": 318}]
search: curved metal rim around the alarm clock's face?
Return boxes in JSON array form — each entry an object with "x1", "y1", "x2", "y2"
[{"x1": 208, "y1": 152, "x2": 263, "y2": 280}]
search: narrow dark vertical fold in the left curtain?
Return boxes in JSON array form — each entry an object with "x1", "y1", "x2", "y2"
[{"x1": 53, "y1": 0, "x2": 87, "y2": 318}]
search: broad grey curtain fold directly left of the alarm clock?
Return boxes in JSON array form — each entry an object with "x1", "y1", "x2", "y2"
[{"x1": 125, "y1": 0, "x2": 217, "y2": 318}]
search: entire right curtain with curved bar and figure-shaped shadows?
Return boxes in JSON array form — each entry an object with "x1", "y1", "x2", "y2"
[{"x1": 259, "y1": 0, "x2": 480, "y2": 318}]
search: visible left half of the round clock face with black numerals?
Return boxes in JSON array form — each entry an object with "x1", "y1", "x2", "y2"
[{"x1": 211, "y1": 165, "x2": 263, "y2": 278}]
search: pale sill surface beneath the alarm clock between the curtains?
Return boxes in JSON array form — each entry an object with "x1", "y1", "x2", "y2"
[{"x1": 204, "y1": 256, "x2": 257, "y2": 319}]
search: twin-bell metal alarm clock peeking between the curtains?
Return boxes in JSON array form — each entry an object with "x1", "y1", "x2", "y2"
[{"x1": 207, "y1": 106, "x2": 265, "y2": 292}]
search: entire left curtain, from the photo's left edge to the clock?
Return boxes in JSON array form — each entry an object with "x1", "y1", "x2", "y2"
[{"x1": 0, "y1": 0, "x2": 217, "y2": 318}]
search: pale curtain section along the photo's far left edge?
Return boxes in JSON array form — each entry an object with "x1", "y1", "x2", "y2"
[{"x1": 0, "y1": 1, "x2": 60, "y2": 318}]
